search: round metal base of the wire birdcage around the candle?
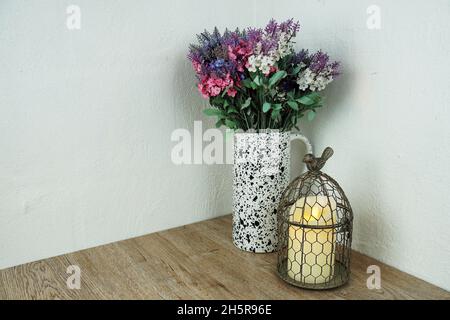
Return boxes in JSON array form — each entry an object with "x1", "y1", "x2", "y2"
[{"x1": 277, "y1": 258, "x2": 350, "y2": 290}]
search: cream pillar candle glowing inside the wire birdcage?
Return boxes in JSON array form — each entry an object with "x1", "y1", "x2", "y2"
[{"x1": 287, "y1": 196, "x2": 336, "y2": 284}]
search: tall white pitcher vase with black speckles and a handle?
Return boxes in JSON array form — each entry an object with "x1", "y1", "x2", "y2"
[{"x1": 233, "y1": 132, "x2": 312, "y2": 253}]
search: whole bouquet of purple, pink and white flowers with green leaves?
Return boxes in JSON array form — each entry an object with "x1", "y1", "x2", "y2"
[{"x1": 188, "y1": 19, "x2": 339, "y2": 132}]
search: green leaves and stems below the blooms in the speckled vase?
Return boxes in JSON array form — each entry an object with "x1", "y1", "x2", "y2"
[{"x1": 203, "y1": 65, "x2": 328, "y2": 131}]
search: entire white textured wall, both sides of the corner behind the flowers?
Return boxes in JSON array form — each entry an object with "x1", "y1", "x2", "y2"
[{"x1": 0, "y1": 0, "x2": 450, "y2": 289}]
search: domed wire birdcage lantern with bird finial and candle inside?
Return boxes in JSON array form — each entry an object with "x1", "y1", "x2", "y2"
[{"x1": 277, "y1": 147, "x2": 353, "y2": 289}]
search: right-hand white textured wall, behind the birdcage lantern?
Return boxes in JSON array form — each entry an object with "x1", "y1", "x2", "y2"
[{"x1": 257, "y1": 0, "x2": 450, "y2": 290}]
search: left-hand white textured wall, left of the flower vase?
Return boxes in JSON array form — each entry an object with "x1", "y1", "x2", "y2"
[{"x1": 0, "y1": 0, "x2": 253, "y2": 268}]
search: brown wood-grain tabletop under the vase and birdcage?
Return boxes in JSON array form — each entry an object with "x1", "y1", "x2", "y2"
[{"x1": 0, "y1": 216, "x2": 450, "y2": 299}]
